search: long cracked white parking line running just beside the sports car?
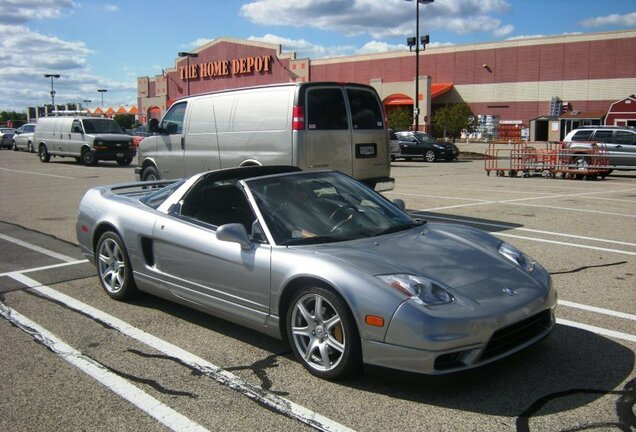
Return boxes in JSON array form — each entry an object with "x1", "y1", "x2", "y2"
[{"x1": 9, "y1": 272, "x2": 352, "y2": 432}]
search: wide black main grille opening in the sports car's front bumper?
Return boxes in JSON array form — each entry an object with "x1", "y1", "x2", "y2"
[{"x1": 481, "y1": 309, "x2": 552, "y2": 361}]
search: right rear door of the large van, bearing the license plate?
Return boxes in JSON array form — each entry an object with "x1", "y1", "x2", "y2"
[{"x1": 346, "y1": 86, "x2": 391, "y2": 184}]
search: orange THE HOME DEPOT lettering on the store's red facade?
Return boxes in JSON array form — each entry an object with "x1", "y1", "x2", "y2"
[{"x1": 179, "y1": 55, "x2": 272, "y2": 80}]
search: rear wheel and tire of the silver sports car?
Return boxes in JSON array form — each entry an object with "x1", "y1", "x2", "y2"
[{"x1": 95, "y1": 231, "x2": 137, "y2": 300}]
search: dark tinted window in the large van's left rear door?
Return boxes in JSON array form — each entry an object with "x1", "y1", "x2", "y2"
[{"x1": 306, "y1": 88, "x2": 349, "y2": 130}]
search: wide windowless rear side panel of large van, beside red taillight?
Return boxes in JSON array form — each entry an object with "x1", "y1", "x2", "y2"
[{"x1": 214, "y1": 87, "x2": 295, "y2": 168}]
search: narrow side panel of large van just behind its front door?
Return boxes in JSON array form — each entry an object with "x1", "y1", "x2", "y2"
[{"x1": 184, "y1": 96, "x2": 221, "y2": 175}]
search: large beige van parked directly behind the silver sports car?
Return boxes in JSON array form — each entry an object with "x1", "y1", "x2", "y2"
[{"x1": 135, "y1": 82, "x2": 395, "y2": 190}]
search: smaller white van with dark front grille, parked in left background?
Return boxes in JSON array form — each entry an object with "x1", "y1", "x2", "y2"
[{"x1": 33, "y1": 117, "x2": 136, "y2": 166}]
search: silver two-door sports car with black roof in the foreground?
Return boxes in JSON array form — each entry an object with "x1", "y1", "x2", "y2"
[{"x1": 77, "y1": 166, "x2": 557, "y2": 379}]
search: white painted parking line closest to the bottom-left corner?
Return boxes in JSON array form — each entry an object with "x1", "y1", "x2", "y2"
[{"x1": 0, "y1": 302, "x2": 208, "y2": 432}]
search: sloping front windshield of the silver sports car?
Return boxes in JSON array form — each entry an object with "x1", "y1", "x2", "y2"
[{"x1": 247, "y1": 172, "x2": 419, "y2": 245}]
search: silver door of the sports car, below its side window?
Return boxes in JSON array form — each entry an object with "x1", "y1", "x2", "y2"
[{"x1": 153, "y1": 215, "x2": 271, "y2": 325}]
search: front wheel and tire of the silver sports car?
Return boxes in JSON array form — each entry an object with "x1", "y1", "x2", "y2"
[{"x1": 286, "y1": 287, "x2": 362, "y2": 380}]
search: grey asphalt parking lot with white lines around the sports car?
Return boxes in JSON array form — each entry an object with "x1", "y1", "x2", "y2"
[{"x1": 0, "y1": 151, "x2": 636, "y2": 431}]
